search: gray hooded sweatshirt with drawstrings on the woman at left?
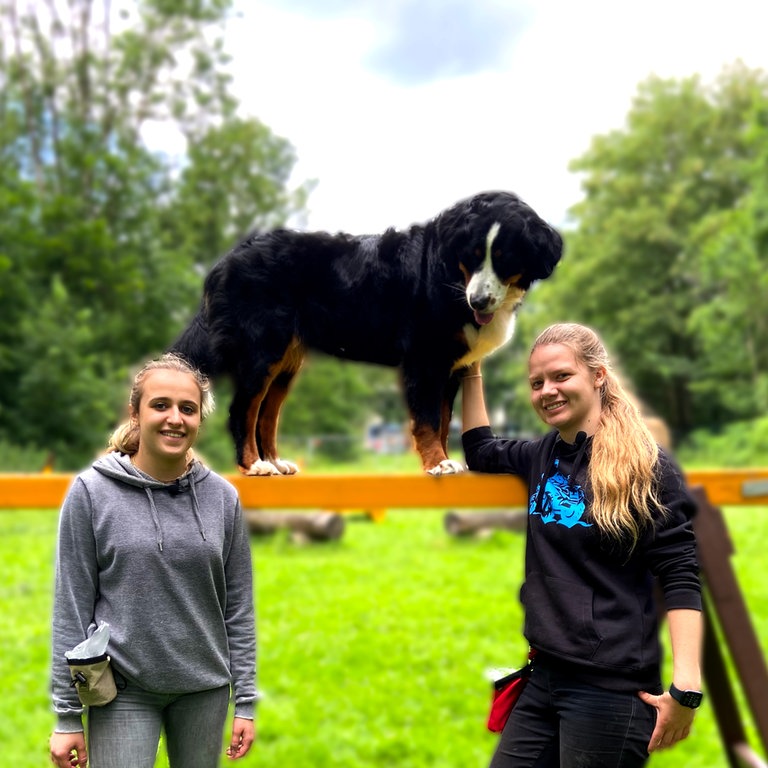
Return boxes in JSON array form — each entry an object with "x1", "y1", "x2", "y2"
[{"x1": 51, "y1": 453, "x2": 257, "y2": 732}]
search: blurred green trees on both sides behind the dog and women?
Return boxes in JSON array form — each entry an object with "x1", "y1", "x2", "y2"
[{"x1": 0, "y1": 0, "x2": 768, "y2": 471}]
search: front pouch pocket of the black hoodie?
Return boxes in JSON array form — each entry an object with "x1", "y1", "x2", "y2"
[{"x1": 520, "y1": 573, "x2": 602, "y2": 661}]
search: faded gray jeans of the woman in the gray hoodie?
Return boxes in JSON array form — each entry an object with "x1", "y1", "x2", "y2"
[{"x1": 88, "y1": 683, "x2": 229, "y2": 768}]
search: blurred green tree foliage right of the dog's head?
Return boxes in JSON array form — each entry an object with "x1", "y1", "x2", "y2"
[{"x1": 512, "y1": 64, "x2": 768, "y2": 435}]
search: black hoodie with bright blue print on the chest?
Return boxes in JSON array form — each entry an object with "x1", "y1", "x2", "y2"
[{"x1": 463, "y1": 427, "x2": 701, "y2": 693}]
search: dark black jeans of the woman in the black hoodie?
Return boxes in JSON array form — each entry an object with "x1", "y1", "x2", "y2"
[{"x1": 491, "y1": 665, "x2": 656, "y2": 768}]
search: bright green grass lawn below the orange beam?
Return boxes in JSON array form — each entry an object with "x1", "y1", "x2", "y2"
[{"x1": 0, "y1": 504, "x2": 768, "y2": 768}]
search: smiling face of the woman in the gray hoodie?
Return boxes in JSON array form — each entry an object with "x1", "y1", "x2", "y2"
[{"x1": 131, "y1": 368, "x2": 202, "y2": 482}]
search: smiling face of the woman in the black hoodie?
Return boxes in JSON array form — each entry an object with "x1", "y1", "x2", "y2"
[{"x1": 528, "y1": 344, "x2": 606, "y2": 443}]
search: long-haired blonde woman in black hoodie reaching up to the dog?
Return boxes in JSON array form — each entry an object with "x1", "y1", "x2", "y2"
[{"x1": 463, "y1": 323, "x2": 702, "y2": 768}]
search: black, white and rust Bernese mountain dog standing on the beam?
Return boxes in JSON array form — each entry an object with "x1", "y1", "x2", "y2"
[{"x1": 171, "y1": 192, "x2": 563, "y2": 475}]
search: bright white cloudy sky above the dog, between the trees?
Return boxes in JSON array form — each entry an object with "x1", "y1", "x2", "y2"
[{"x1": 222, "y1": 0, "x2": 768, "y2": 234}]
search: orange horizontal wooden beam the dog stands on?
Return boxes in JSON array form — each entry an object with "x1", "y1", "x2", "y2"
[{"x1": 0, "y1": 469, "x2": 768, "y2": 510}]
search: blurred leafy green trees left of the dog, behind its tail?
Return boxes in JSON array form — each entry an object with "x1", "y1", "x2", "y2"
[{"x1": 0, "y1": 0, "x2": 308, "y2": 468}]
